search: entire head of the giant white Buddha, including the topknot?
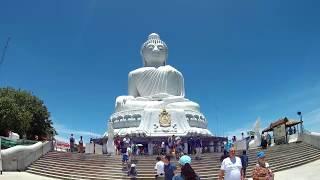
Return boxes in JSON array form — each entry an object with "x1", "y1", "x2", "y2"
[{"x1": 141, "y1": 33, "x2": 168, "y2": 67}]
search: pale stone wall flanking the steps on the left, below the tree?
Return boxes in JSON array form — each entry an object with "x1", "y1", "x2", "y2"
[{"x1": 1, "y1": 141, "x2": 52, "y2": 171}]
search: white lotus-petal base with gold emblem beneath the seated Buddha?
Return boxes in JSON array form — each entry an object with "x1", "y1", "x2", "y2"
[{"x1": 110, "y1": 108, "x2": 212, "y2": 137}]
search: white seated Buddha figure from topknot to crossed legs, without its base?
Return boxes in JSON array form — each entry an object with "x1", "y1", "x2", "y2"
[{"x1": 115, "y1": 33, "x2": 199, "y2": 112}]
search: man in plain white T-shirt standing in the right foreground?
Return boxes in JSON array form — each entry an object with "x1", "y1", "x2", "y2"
[{"x1": 219, "y1": 147, "x2": 244, "y2": 180}]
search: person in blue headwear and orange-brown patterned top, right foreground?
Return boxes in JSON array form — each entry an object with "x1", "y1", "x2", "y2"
[{"x1": 252, "y1": 151, "x2": 274, "y2": 180}]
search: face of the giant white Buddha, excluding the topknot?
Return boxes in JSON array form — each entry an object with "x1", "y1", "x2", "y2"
[{"x1": 142, "y1": 42, "x2": 167, "y2": 66}]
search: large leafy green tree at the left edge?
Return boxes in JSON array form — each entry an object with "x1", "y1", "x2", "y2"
[{"x1": 0, "y1": 87, "x2": 57, "y2": 139}]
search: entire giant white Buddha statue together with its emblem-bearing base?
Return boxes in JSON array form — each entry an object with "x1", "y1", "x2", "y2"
[{"x1": 109, "y1": 33, "x2": 212, "y2": 136}]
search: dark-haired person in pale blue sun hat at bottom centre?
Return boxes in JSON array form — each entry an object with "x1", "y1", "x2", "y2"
[{"x1": 172, "y1": 155, "x2": 200, "y2": 180}]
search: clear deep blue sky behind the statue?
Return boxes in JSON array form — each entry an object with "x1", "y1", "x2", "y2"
[{"x1": 0, "y1": 0, "x2": 320, "y2": 143}]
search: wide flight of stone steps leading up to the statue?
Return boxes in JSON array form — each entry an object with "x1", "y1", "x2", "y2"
[{"x1": 27, "y1": 143, "x2": 320, "y2": 179}]
